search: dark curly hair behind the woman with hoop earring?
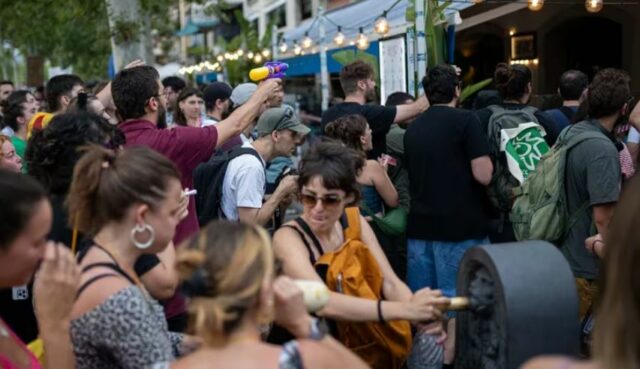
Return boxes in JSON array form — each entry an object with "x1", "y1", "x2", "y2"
[{"x1": 25, "y1": 112, "x2": 125, "y2": 195}]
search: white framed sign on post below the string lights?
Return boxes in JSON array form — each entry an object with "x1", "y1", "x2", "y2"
[{"x1": 379, "y1": 35, "x2": 407, "y2": 105}]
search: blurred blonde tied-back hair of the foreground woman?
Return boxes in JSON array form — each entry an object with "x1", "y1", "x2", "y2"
[{"x1": 177, "y1": 221, "x2": 274, "y2": 346}]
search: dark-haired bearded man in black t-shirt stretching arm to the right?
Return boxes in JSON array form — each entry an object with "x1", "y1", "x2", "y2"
[{"x1": 322, "y1": 60, "x2": 429, "y2": 159}]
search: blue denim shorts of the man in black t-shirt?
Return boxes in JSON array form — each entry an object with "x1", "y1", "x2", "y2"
[{"x1": 407, "y1": 238, "x2": 489, "y2": 297}]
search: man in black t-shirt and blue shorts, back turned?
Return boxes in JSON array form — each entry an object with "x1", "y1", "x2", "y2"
[{"x1": 404, "y1": 65, "x2": 493, "y2": 296}]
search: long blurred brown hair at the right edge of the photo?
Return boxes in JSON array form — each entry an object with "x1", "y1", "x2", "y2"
[{"x1": 594, "y1": 175, "x2": 640, "y2": 369}]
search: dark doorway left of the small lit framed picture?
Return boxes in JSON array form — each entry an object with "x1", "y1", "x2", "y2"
[{"x1": 455, "y1": 32, "x2": 505, "y2": 84}]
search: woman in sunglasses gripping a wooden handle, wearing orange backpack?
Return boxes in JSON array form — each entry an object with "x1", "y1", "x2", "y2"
[{"x1": 273, "y1": 141, "x2": 449, "y2": 366}]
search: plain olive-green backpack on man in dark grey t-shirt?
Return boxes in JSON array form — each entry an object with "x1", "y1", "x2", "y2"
[{"x1": 509, "y1": 126, "x2": 610, "y2": 242}]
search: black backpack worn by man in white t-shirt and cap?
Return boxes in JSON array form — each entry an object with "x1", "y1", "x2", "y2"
[{"x1": 193, "y1": 147, "x2": 262, "y2": 227}]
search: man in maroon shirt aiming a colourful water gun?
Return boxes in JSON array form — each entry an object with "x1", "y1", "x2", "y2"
[{"x1": 111, "y1": 66, "x2": 281, "y2": 245}]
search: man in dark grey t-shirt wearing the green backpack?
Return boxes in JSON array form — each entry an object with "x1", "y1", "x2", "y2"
[{"x1": 560, "y1": 69, "x2": 631, "y2": 317}]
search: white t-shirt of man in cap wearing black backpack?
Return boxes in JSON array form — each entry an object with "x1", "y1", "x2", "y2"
[{"x1": 221, "y1": 142, "x2": 267, "y2": 220}]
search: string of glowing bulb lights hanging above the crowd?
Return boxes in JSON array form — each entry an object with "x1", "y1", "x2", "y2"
[{"x1": 180, "y1": 0, "x2": 639, "y2": 74}]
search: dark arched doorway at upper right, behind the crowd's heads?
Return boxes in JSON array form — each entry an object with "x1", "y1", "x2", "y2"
[{"x1": 540, "y1": 17, "x2": 622, "y2": 93}]
